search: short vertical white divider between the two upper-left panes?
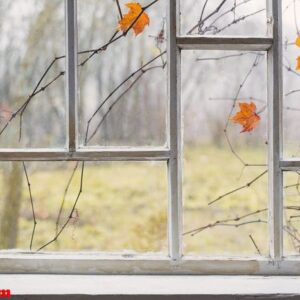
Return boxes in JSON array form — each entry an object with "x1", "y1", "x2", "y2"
[{"x1": 65, "y1": 0, "x2": 77, "y2": 152}]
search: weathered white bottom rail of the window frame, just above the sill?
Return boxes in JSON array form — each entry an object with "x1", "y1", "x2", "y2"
[{"x1": 0, "y1": 251, "x2": 300, "y2": 275}]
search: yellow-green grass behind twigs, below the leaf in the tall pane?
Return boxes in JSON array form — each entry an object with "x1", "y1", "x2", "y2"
[{"x1": 183, "y1": 146, "x2": 268, "y2": 255}]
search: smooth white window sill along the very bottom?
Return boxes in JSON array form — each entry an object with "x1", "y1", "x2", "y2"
[{"x1": 0, "y1": 274, "x2": 300, "y2": 300}]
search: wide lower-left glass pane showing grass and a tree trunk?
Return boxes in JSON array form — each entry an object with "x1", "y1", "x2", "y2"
[{"x1": 0, "y1": 162, "x2": 167, "y2": 253}]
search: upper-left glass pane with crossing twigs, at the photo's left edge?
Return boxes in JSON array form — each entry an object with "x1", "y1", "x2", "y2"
[{"x1": 0, "y1": 0, "x2": 66, "y2": 148}]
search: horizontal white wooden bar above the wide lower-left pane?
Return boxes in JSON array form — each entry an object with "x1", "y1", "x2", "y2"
[{"x1": 0, "y1": 148, "x2": 170, "y2": 161}]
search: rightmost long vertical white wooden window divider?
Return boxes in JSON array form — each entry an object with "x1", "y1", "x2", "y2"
[{"x1": 267, "y1": 0, "x2": 283, "y2": 261}]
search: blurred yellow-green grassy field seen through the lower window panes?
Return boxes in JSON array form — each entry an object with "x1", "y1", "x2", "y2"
[{"x1": 0, "y1": 145, "x2": 297, "y2": 255}]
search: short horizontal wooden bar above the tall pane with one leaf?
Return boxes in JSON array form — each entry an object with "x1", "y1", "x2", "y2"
[{"x1": 177, "y1": 36, "x2": 273, "y2": 51}]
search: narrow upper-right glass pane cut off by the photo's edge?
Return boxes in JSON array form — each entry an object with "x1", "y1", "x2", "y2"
[{"x1": 282, "y1": 0, "x2": 300, "y2": 158}]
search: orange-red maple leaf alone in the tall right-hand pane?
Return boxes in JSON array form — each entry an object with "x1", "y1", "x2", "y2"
[{"x1": 230, "y1": 102, "x2": 260, "y2": 132}]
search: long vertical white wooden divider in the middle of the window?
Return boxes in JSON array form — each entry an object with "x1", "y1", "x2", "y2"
[{"x1": 167, "y1": 0, "x2": 182, "y2": 260}]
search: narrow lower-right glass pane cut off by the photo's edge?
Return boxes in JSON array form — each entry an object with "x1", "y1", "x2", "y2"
[{"x1": 283, "y1": 172, "x2": 300, "y2": 256}]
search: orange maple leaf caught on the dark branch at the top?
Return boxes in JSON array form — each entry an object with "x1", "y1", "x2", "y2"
[{"x1": 119, "y1": 2, "x2": 150, "y2": 36}]
